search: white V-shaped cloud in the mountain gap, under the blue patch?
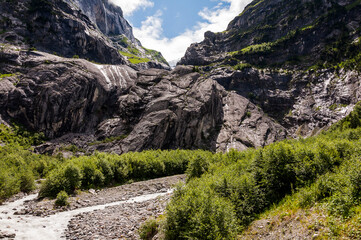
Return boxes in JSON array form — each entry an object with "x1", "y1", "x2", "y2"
[{"x1": 134, "y1": 0, "x2": 251, "y2": 62}]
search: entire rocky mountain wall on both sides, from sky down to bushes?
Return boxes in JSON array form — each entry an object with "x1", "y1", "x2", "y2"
[{"x1": 0, "y1": 0, "x2": 361, "y2": 153}]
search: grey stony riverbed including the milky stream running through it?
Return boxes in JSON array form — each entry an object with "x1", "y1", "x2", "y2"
[{"x1": 0, "y1": 175, "x2": 185, "y2": 240}]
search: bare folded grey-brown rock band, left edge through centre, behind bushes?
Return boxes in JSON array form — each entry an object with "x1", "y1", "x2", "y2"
[{"x1": 0, "y1": 47, "x2": 286, "y2": 153}]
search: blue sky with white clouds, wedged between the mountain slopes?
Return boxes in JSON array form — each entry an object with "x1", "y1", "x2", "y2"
[{"x1": 111, "y1": 0, "x2": 251, "y2": 63}]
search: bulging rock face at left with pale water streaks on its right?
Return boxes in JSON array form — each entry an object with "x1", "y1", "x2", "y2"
[{"x1": 0, "y1": 46, "x2": 136, "y2": 138}]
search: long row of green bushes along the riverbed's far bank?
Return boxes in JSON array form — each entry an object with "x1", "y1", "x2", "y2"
[{"x1": 39, "y1": 150, "x2": 202, "y2": 197}]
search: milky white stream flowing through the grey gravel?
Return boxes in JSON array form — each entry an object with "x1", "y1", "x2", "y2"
[{"x1": 0, "y1": 191, "x2": 171, "y2": 240}]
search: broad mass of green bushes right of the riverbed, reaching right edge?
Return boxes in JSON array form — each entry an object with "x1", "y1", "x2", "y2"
[{"x1": 165, "y1": 105, "x2": 361, "y2": 239}]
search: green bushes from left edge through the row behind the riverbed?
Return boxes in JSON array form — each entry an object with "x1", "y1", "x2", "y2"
[{"x1": 0, "y1": 122, "x2": 205, "y2": 202}]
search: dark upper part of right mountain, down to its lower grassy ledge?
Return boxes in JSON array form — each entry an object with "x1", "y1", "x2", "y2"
[{"x1": 180, "y1": 0, "x2": 361, "y2": 69}]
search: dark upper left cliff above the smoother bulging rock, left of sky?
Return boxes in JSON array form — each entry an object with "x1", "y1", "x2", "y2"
[{"x1": 0, "y1": 0, "x2": 169, "y2": 69}]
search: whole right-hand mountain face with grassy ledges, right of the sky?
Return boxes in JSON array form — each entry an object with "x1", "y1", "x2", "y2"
[{"x1": 179, "y1": 0, "x2": 361, "y2": 136}]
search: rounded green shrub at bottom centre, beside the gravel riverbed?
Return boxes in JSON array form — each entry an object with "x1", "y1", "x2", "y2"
[{"x1": 165, "y1": 180, "x2": 238, "y2": 239}]
